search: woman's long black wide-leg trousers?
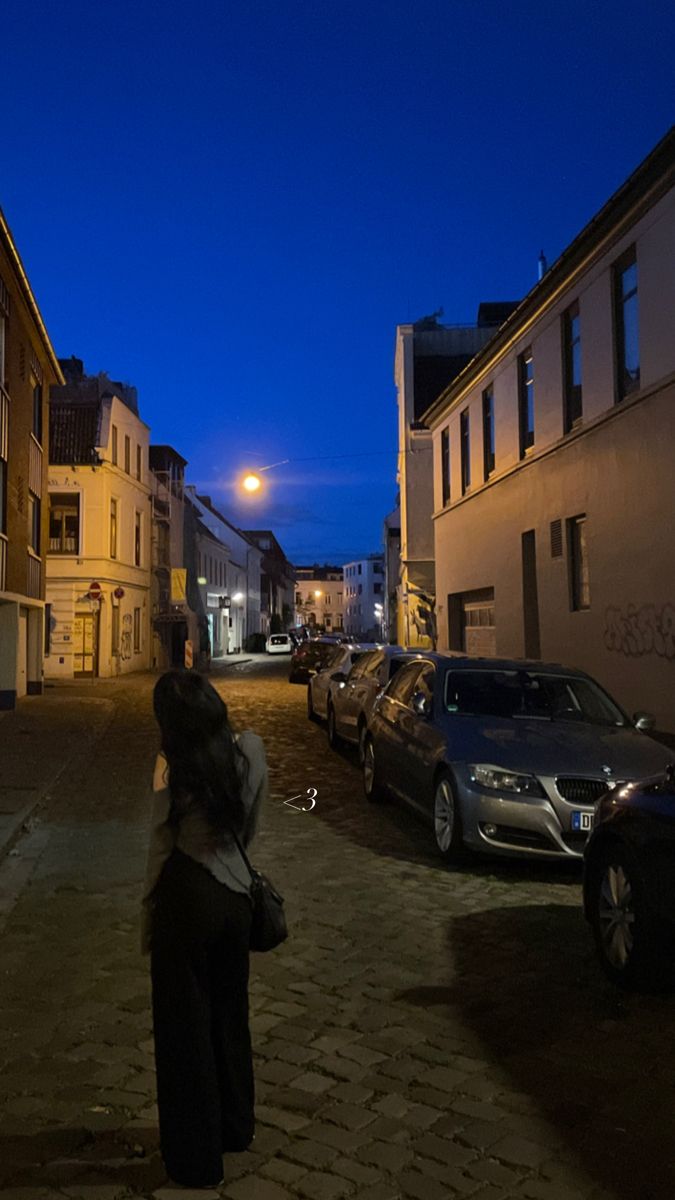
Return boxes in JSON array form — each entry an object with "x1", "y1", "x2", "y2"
[{"x1": 151, "y1": 850, "x2": 253, "y2": 1187}]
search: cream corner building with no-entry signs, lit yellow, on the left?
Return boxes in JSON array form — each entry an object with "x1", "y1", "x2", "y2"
[{"x1": 44, "y1": 359, "x2": 151, "y2": 678}]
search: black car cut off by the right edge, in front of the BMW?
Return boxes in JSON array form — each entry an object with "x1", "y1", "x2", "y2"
[{"x1": 584, "y1": 768, "x2": 675, "y2": 990}]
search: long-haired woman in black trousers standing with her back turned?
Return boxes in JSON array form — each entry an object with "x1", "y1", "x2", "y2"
[{"x1": 143, "y1": 671, "x2": 268, "y2": 1188}]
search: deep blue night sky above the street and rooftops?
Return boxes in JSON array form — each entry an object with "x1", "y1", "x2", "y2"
[{"x1": 0, "y1": 0, "x2": 675, "y2": 562}]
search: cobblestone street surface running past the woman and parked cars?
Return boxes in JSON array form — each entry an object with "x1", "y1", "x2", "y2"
[{"x1": 0, "y1": 658, "x2": 675, "y2": 1200}]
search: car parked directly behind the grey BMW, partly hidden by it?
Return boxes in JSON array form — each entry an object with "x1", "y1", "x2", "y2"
[{"x1": 325, "y1": 646, "x2": 419, "y2": 763}]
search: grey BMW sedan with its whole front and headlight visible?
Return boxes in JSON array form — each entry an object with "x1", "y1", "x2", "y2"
[{"x1": 364, "y1": 653, "x2": 670, "y2": 859}]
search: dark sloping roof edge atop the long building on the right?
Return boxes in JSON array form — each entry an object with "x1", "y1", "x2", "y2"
[{"x1": 423, "y1": 126, "x2": 675, "y2": 425}]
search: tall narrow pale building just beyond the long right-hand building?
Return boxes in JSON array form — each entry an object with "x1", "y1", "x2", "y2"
[{"x1": 394, "y1": 301, "x2": 515, "y2": 646}]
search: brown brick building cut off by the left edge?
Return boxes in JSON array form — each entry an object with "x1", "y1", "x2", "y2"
[{"x1": 0, "y1": 210, "x2": 62, "y2": 708}]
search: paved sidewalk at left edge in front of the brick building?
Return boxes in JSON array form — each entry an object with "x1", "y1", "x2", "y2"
[{"x1": 0, "y1": 685, "x2": 114, "y2": 859}]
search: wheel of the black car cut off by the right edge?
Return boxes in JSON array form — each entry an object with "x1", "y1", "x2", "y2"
[{"x1": 587, "y1": 841, "x2": 674, "y2": 991}]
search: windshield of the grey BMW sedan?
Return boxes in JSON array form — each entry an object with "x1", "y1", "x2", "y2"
[{"x1": 446, "y1": 670, "x2": 626, "y2": 725}]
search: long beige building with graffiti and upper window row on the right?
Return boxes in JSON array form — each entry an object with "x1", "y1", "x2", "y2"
[{"x1": 424, "y1": 131, "x2": 675, "y2": 731}]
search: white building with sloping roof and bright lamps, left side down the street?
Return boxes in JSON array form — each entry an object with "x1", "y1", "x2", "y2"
[{"x1": 185, "y1": 485, "x2": 263, "y2": 658}]
